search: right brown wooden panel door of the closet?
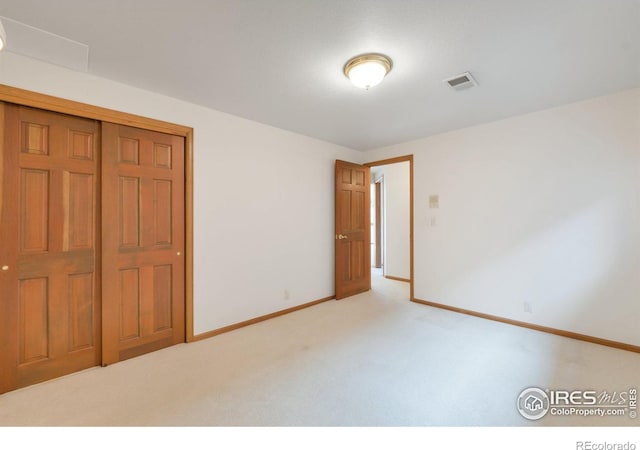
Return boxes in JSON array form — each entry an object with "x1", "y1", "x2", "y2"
[{"x1": 102, "y1": 123, "x2": 185, "y2": 365}]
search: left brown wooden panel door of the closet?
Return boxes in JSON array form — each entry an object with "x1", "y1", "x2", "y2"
[{"x1": 0, "y1": 104, "x2": 101, "y2": 392}]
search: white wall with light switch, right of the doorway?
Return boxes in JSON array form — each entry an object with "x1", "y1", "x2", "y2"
[{"x1": 367, "y1": 89, "x2": 640, "y2": 345}]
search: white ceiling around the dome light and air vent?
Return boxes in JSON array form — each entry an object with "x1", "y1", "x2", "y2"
[{"x1": 0, "y1": 0, "x2": 640, "y2": 150}]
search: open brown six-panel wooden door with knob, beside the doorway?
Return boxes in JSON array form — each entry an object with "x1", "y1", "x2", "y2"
[{"x1": 335, "y1": 161, "x2": 371, "y2": 300}]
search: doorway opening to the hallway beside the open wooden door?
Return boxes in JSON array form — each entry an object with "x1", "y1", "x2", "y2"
[{"x1": 364, "y1": 155, "x2": 414, "y2": 300}]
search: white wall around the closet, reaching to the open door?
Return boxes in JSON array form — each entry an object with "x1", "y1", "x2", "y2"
[{"x1": 0, "y1": 52, "x2": 361, "y2": 334}]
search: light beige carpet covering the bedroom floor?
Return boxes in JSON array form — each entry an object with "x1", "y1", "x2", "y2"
[{"x1": 0, "y1": 276, "x2": 640, "y2": 426}]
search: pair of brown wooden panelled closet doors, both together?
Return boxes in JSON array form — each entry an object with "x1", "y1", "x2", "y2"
[{"x1": 0, "y1": 103, "x2": 185, "y2": 393}]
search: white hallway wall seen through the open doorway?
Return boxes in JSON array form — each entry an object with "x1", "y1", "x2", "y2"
[{"x1": 372, "y1": 161, "x2": 411, "y2": 280}]
